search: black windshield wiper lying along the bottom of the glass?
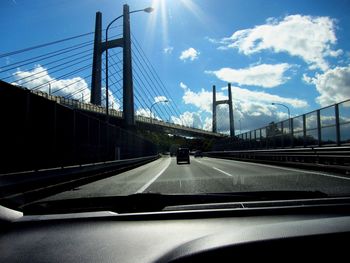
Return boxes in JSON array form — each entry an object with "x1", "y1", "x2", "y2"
[{"x1": 22, "y1": 191, "x2": 328, "y2": 215}]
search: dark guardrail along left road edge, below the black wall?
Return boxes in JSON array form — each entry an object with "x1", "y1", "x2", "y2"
[{"x1": 0, "y1": 155, "x2": 159, "y2": 206}]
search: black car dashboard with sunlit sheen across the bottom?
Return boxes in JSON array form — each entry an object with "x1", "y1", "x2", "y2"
[{"x1": 0, "y1": 198, "x2": 350, "y2": 262}]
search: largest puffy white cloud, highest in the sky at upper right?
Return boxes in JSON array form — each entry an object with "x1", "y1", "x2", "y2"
[{"x1": 220, "y1": 15, "x2": 342, "y2": 70}]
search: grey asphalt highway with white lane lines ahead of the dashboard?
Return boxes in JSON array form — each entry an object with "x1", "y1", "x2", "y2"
[{"x1": 44, "y1": 157, "x2": 350, "y2": 199}]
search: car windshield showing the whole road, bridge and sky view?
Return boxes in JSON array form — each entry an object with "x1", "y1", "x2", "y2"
[{"x1": 0, "y1": 0, "x2": 350, "y2": 210}]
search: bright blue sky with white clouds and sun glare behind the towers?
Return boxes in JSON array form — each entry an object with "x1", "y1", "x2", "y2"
[{"x1": 0, "y1": 0, "x2": 350, "y2": 132}]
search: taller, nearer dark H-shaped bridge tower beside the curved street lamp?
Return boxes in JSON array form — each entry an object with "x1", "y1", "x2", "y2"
[{"x1": 90, "y1": 5, "x2": 135, "y2": 127}]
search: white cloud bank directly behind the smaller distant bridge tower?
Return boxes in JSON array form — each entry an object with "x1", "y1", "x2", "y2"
[{"x1": 179, "y1": 86, "x2": 308, "y2": 133}]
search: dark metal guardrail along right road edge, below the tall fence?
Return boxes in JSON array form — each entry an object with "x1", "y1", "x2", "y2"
[{"x1": 204, "y1": 147, "x2": 350, "y2": 174}]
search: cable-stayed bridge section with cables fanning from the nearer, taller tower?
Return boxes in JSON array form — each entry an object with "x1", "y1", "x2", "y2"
[{"x1": 0, "y1": 5, "x2": 227, "y2": 140}]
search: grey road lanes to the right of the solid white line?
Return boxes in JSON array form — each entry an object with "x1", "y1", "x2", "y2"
[{"x1": 145, "y1": 158, "x2": 350, "y2": 194}]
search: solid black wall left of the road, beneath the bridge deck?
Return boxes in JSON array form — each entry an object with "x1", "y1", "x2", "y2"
[{"x1": 0, "y1": 81, "x2": 157, "y2": 173}]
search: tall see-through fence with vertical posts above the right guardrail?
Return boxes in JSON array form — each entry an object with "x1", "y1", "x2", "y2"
[{"x1": 214, "y1": 100, "x2": 350, "y2": 150}]
